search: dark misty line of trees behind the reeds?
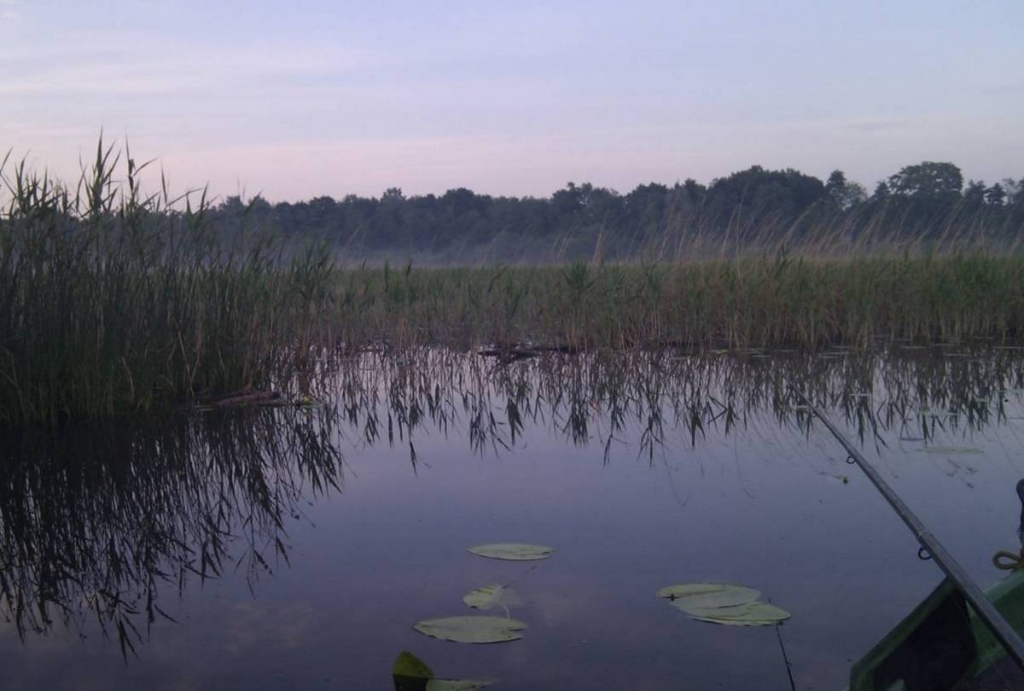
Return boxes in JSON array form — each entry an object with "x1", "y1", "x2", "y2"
[{"x1": 212, "y1": 162, "x2": 1024, "y2": 262}]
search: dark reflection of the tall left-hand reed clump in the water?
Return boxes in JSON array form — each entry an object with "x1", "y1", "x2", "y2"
[{"x1": 0, "y1": 408, "x2": 342, "y2": 653}]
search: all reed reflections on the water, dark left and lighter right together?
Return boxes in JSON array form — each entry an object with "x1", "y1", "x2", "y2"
[{"x1": 0, "y1": 349, "x2": 1024, "y2": 653}]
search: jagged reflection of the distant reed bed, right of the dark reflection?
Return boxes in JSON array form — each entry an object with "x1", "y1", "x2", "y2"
[{"x1": 337, "y1": 349, "x2": 1024, "y2": 465}]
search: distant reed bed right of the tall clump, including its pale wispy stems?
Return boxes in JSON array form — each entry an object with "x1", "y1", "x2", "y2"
[{"x1": 323, "y1": 180, "x2": 1024, "y2": 349}]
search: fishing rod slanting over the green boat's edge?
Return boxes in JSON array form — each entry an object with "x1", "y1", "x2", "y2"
[{"x1": 786, "y1": 380, "x2": 1024, "y2": 671}]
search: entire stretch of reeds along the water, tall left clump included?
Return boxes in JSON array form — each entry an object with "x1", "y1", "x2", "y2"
[{"x1": 0, "y1": 141, "x2": 1024, "y2": 426}]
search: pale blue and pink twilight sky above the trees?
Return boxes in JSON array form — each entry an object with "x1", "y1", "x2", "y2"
[{"x1": 0, "y1": 0, "x2": 1024, "y2": 202}]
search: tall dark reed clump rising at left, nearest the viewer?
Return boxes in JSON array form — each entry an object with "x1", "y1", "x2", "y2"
[{"x1": 0, "y1": 140, "x2": 332, "y2": 425}]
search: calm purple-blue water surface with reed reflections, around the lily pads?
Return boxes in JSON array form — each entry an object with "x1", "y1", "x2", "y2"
[{"x1": 0, "y1": 347, "x2": 1024, "y2": 691}]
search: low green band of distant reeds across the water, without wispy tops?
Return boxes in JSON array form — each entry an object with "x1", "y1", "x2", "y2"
[{"x1": 333, "y1": 250, "x2": 1024, "y2": 350}]
